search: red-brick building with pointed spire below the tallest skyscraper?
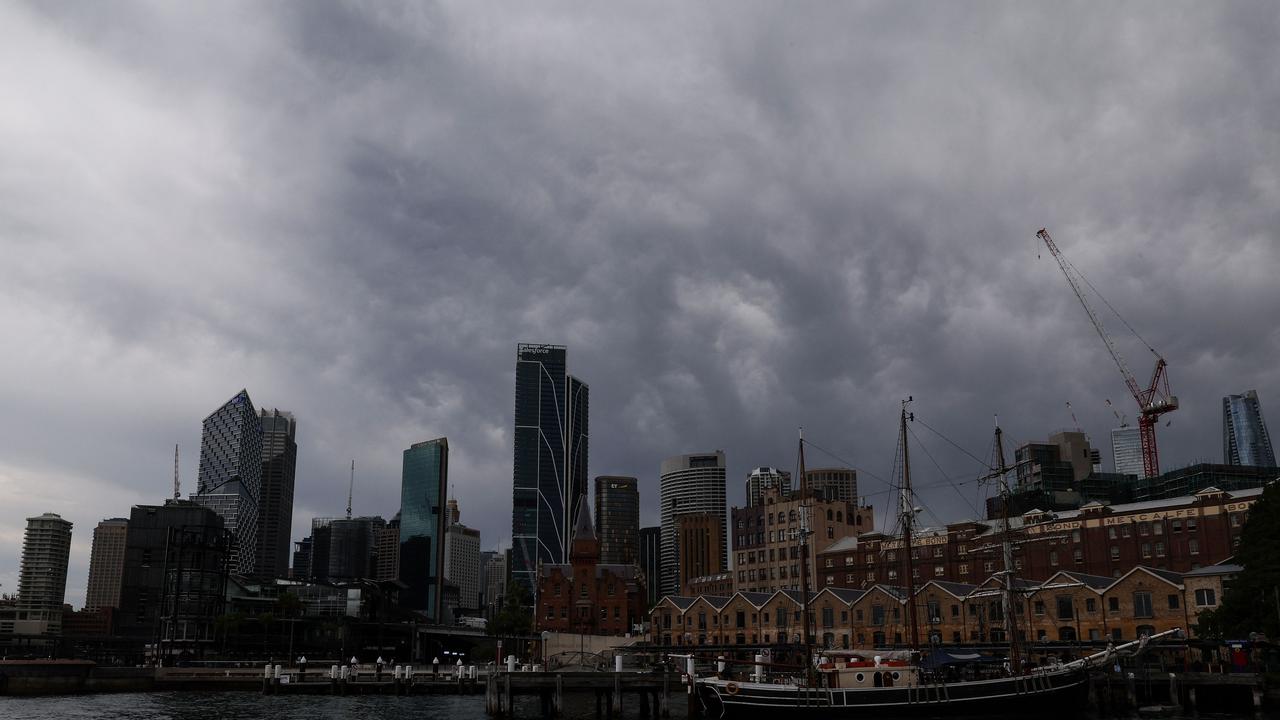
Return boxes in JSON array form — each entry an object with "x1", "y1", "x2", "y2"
[{"x1": 535, "y1": 497, "x2": 646, "y2": 635}]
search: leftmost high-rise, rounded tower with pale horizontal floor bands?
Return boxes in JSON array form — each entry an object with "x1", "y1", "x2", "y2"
[{"x1": 15, "y1": 512, "x2": 72, "y2": 635}]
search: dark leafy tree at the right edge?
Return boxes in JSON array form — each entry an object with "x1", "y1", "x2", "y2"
[{"x1": 1199, "y1": 482, "x2": 1280, "y2": 639}]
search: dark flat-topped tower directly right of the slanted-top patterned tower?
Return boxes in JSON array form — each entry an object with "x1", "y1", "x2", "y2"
[{"x1": 256, "y1": 409, "x2": 298, "y2": 578}]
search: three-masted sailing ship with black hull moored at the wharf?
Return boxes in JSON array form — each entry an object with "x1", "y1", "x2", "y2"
[{"x1": 690, "y1": 397, "x2": 1179, "y2": 720}]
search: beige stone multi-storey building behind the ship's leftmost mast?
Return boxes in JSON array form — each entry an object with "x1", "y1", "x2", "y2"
[{"x1": 731, "y1": 486, "x2": 876, "y2": 592}]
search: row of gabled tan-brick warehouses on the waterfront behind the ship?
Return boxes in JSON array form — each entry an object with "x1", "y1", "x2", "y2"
[{"x1": 649, "y1": 556, "x2": 1238, "y2": 652}]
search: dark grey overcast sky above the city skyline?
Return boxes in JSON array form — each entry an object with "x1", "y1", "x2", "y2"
[{"x1": 0, "y1": 1, "x2": 1280, "y2": 606}]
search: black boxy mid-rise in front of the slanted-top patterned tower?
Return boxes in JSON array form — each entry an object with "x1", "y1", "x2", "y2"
[{"x1": 115, "y1": 500, "x2": 236, "y2": 650}]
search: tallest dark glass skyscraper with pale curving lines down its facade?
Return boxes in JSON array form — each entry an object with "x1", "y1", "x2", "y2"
[{"x1": 511, "y1": 343, "x2": 589, "y2": 597}]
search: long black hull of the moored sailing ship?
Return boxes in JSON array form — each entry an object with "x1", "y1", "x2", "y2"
[{"x1": 698, "y1": 670, "x2": 1088, "y2": 720}]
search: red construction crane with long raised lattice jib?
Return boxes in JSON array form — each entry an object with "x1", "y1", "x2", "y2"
[{"x1": 1036, "y1": 228, "x2": 1178, "y2": 478}]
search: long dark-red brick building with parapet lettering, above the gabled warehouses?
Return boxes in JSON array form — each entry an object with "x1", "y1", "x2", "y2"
[{"x1": 815, "y1": 487, "x2": 1262, "y2": 589}]
